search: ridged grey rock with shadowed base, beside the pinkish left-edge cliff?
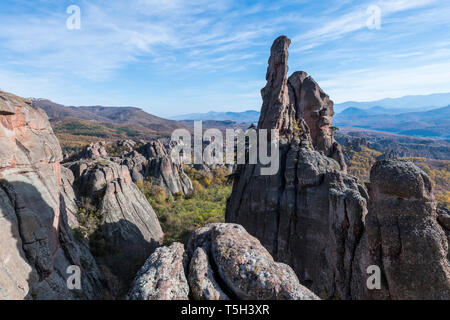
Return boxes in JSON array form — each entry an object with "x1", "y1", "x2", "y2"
[{"x1": 65, "y1": 158, "x2": 164, "y2": 282}]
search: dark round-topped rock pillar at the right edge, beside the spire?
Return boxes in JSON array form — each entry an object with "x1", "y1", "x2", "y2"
[{"x1": 352, "y1": 159, "x2": 450, "y2": 300}]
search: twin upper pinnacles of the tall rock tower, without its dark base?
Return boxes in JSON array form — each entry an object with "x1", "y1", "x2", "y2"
[{"x1": 258, "y1": 36, "x2": 346, "y2": 171}]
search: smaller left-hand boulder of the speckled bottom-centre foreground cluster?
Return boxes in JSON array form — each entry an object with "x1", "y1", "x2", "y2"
[{"x1": 129, "y1": 242, "x2": 189, "y2": 300}]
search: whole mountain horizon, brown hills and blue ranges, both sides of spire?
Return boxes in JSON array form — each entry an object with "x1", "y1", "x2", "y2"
[{"x1": 32, "y1": 90, "x2": 450, "y2": 145}]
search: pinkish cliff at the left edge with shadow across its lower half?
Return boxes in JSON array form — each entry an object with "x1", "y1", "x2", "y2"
[{"x1": 0, "y1": 92, "x2": 103, "y2": 299}]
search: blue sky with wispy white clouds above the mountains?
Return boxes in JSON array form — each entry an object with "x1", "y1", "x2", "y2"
[{"x1": 0, "y1": 0, "x2": 450, "y2": 116}]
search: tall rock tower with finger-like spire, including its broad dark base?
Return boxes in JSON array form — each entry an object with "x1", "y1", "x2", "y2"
[{"x1": 226, "y1": 37, "x2": 360, "y2": 298}]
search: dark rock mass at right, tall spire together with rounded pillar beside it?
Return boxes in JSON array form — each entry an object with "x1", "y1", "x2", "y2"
[{"x1": 226, "y1": 36, "x2": 450, "y2": 299}]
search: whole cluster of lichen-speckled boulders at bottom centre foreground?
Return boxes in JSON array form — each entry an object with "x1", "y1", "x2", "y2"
[{"x1": 129, "y1": 223, "x2": 318, "y2": 300}]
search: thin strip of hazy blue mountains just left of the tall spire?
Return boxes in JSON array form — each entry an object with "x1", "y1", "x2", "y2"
[{"x1": 171, "y1": 110, "x2": 259, "y2": 124}]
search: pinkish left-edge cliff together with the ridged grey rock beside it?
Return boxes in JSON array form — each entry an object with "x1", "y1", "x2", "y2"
[{"x1": 0, "y1": 92, "x2": 163, "y2": 299}]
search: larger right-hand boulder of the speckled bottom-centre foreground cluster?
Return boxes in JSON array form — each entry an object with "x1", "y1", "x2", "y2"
[{"x1": 211, "y1": 224, "x2": 317, "y2": 300}]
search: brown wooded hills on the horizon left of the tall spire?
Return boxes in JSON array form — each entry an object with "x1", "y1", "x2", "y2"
[{"x1": 31, "y1": 98, "x2": 248, "y2": 150}]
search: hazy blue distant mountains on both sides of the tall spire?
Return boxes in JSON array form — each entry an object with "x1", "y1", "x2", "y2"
[{"x1": 172, "y1": 93, "x2": 450, "y2": 139}]
